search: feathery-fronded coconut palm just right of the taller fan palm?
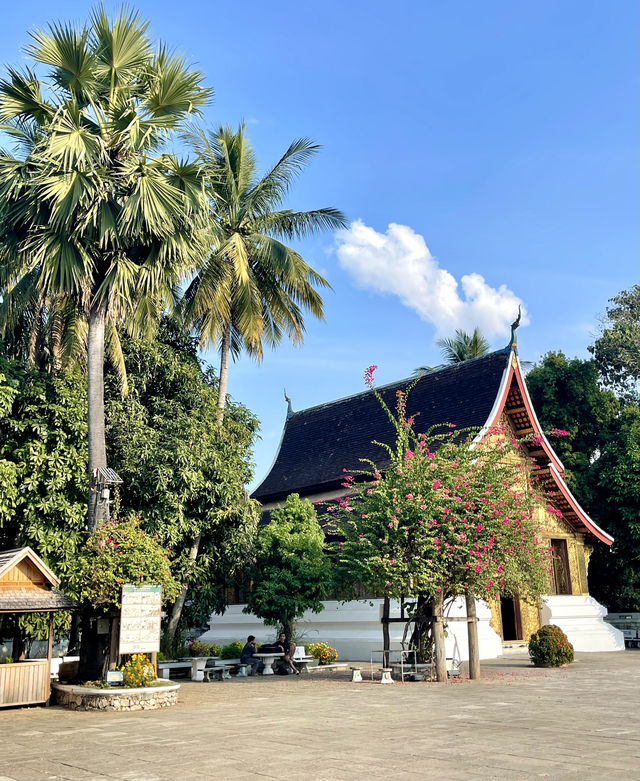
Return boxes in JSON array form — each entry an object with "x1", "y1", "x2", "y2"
[{"x1": 184, "y1": 124, "x2": 346, "y2": 425}]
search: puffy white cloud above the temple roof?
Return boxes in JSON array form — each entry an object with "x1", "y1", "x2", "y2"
[{"x1": 336, "y1": 220, "x2": 529, "y2": 339}]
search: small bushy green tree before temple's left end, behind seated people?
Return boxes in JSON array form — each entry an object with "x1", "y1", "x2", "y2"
[{"x1": 245, "y1": 494, "x2": 331, "y2": 638}]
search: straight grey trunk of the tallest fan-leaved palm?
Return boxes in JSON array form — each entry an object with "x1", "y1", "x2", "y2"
[{"x1": 87, "y1": 305, "x2": 109, "y2": 533}]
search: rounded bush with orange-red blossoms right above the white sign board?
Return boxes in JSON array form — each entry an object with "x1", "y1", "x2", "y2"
[{"x1": 77, "y1": 516, "x2": 180, "y2": 611}]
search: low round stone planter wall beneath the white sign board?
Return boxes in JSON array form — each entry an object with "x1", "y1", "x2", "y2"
[{"x1": 51, "y1": 683, "x2": 180, "y2": 711}]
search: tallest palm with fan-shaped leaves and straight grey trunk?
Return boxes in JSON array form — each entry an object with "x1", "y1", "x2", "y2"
[{"x1": 0, "y1": 7, "x2": 210, "y2": 530}]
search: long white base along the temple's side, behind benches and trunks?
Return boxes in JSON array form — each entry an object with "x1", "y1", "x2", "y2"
[{"x1": 198, "y1": 599, "x2": 502, "y2": 661}]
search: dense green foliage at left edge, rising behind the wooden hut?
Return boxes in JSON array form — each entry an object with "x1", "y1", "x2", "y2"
[{"x1": 0, "y1": 355, "x2": 88, "y2": 580}]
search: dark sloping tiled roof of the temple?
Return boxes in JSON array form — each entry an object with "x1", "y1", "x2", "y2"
[{"x1": 252, "y1": 350, "x2": 511, "y2": 503}]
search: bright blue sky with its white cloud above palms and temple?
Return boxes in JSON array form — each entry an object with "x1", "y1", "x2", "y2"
[{"x1": 0, "y1": 0, "x2": 639, "y2": 488}]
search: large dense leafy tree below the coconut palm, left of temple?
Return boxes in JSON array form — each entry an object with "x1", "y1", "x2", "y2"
[{"x1": 107, "y1": 320, "x2": 257, "y2": 645}]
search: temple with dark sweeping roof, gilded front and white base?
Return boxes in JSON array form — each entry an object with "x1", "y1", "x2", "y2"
[{"x1": 202, "y1": 336, "x2": 624, "y2": 659}]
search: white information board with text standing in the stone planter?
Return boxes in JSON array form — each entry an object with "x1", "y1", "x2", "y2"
[{"x1": 119, "y1": 585, "x2": 162, "y2": 654}]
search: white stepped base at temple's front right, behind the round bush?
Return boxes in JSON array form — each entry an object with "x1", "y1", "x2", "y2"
[{"x1": 542, "y1": 595, "x2": 624, "y2": 651}]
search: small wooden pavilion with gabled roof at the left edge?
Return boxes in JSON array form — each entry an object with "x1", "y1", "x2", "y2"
[{"x1": 0, "y1": 548, "x2": 76, "y2": 708}]
